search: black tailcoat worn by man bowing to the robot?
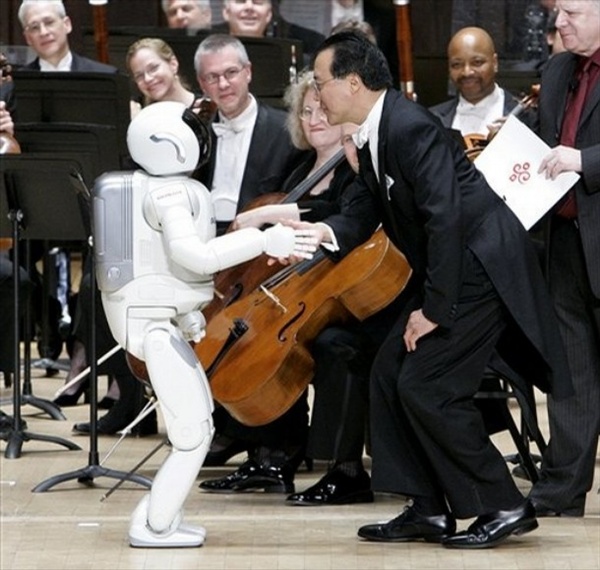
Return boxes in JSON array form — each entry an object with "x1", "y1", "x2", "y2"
[{"x1": 326, "y1": 90, "x2": 572, "y2": 397}]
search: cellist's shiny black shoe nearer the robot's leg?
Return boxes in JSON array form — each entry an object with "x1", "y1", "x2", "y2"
[{"x1": 200, "y1": 459, "x2": 294, "y2": 493}]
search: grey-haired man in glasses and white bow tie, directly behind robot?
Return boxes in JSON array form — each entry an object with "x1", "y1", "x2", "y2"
[{"x1": 194, "y1": 34, "x2": 302, "y2": 231}]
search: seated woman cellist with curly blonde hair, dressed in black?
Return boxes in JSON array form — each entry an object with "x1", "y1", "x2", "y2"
[{"x1": 200, "y1": 72, "x2": 408, "y2": 505}]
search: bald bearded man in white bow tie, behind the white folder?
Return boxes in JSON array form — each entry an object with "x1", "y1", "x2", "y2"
[{"x1": 429, "y1": 27, "x2": 517, "y2": 136}]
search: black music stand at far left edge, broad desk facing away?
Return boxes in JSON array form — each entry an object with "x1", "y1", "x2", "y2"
[{"x1": 0, "y1": 155, "x2": 85, "y2": 459}]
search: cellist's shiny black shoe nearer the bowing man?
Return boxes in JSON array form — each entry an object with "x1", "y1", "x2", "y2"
[{"x1": 286, "y1": 469, "x2": 373, "y2": 506}]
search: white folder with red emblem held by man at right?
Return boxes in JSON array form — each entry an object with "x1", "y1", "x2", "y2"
[{"x1": 474, "y1": 116, "x2": 579, "y2": 229}]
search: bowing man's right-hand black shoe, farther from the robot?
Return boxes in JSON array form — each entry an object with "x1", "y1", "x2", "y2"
[{"x1": 442, "y1": 501, "x2": 538, "y2": 548}]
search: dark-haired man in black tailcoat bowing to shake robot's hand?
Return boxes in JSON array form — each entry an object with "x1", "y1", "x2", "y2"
[{"x1": 302, "y1": 32, "x2": 572, "y2": 548}]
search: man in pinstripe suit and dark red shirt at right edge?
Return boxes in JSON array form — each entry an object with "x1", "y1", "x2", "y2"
[{"x1": 529, "y1": 0, "x2": 600, "y2": 516}]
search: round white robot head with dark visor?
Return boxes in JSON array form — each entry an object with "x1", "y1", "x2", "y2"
[{"x1": 127, "y1": 101, "x2": 210, "y2": 176}]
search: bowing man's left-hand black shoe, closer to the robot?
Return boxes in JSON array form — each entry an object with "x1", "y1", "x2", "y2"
[{"x1": 358, "y1": 507, "x2": 456, "y2": 542}]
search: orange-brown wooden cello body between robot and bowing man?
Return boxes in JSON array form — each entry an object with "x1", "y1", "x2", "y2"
[{"x1": 195, "y1": 230, "x2": 411, "y2": 426}]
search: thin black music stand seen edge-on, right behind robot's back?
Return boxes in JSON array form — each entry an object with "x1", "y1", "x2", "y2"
[{"x1": 32, "y1": 171, "x2": 152, "y2": 493}]
